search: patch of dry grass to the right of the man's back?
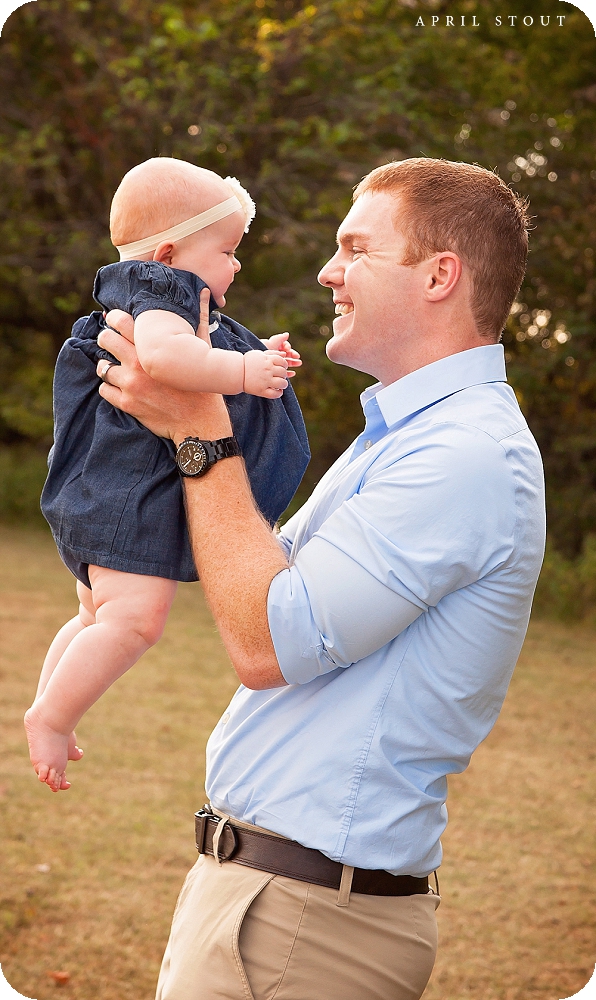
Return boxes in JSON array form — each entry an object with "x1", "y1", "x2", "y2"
[{"x1": 424, "y1": 622, "x2": 596, "y2": 1000}]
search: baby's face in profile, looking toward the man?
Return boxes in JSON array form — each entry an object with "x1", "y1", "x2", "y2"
[{"x1": 172, "y1": 212, "x2": 245, "y2": 307}]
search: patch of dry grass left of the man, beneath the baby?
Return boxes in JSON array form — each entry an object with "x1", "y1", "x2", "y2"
[{"x1": 0, "y1": 530, "x2": 236, "y2": 1000}]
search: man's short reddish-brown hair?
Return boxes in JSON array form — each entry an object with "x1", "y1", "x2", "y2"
[{"x1": 354, "y1": 157, "x2": 529, "y2": 340}]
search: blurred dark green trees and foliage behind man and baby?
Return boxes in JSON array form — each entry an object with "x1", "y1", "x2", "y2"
[{"x1": 0, "y1": 0, "x2": 596, "y2": 558}]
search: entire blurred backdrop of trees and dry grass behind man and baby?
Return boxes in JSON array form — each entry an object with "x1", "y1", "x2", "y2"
[{"x1": 0, "y1": 0, "x2": 596, "y2": 1000}]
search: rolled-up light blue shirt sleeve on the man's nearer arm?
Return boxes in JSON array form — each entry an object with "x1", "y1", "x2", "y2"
[{"x1": 268, "y1": 425, "x2": 515, "y2": 684}]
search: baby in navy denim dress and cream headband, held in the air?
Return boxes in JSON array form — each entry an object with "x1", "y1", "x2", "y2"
[{"x1": 25, "y1": 157, "x2": 310, "y2": 791}]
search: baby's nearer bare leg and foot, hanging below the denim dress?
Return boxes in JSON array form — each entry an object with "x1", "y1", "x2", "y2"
[{"x1": 25, "y1": 566, "x2": 176, "y2": 791}]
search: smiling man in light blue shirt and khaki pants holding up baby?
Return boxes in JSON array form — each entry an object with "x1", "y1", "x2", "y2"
[{"x1": 101, "y1": 159, "x2": 545, "y2": 1000}]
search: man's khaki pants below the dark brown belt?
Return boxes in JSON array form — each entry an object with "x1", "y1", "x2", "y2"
[{"x1": 156, "y1": 855, "x2": 439, "y2": 1000}]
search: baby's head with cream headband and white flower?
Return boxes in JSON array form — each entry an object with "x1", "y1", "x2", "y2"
[{"x1": 110, "y1": 156, "x2": 255, "y2": 306}]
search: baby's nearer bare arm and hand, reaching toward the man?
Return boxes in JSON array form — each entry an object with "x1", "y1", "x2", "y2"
[{"x1": 135, "y1": 309, "x2": 288, "y2": 399}]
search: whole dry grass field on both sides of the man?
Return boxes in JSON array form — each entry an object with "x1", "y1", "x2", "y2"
[{"x1": 0, "y1": 529, "x2": 596, "y2": 1000}]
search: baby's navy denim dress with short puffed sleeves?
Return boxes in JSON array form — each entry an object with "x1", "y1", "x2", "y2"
[{"x1": 41, "y1": 261, "x2": 310, "y2": 587}]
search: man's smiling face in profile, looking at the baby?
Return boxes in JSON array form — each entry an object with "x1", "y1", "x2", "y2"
[{"x1": 318, "y1": 192, "x2": 424, "y2": 384}]
